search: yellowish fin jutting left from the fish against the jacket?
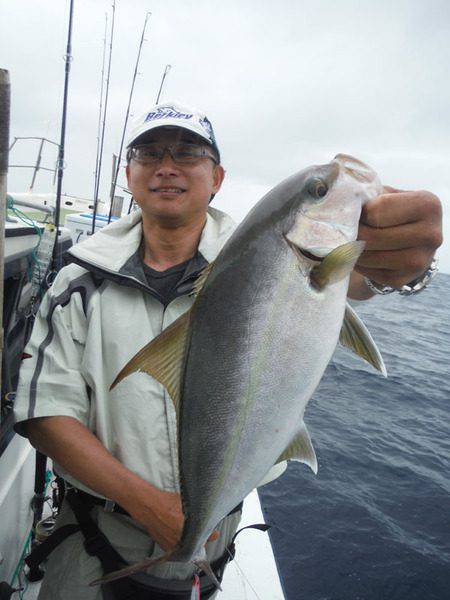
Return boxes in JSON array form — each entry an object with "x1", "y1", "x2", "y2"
[{"x1": 111, "y1": 310, "x2": 191, "y2": 415}]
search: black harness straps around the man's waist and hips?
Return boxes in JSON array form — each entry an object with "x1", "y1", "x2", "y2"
[{"x1": 25, "y1": 488, "x2": 264, "y2": 600}]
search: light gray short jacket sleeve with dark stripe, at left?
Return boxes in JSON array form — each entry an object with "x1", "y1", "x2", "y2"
[{"x1": 14, "y1": 267, "x2": 90, "y2": 435}]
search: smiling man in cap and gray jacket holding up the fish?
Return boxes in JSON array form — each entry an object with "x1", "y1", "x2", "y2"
[{"x1": 12, "y1": 103, "x2": 441, "y2": 600}]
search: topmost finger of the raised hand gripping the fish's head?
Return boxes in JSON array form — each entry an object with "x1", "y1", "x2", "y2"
[{"x1": 361, "y1": 188, "x2": 442, "y2": 227}]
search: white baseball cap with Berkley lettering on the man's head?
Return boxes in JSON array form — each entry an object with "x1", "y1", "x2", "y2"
[{"x1": 127, "y1": 102, "x2": 220, "y2": 161}]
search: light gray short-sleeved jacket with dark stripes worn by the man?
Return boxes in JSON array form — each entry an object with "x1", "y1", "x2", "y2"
[{"x1": 15, "y1": 208, "x2": 234, "y2": 493}]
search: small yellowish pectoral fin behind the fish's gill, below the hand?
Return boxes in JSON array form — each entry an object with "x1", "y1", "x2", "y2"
[{"x1": 310, "y1": 241, "x2": 365, "y2": 290}]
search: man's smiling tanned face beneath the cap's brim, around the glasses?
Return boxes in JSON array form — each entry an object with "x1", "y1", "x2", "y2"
[{"x1": 126, "y1": 128, "x2": 224, "y2": 227}]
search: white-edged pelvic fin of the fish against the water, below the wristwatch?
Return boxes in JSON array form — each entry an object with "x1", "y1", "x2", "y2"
[{"x1": 339, "y1": 304, "x2": 387, "y2": 377}]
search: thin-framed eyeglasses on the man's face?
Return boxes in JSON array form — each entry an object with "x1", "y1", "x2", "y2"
[{"x1": 130, "y1": 142, "x2": 218, "y2": 165}]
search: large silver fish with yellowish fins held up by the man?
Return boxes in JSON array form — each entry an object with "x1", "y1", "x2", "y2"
[{"x1": 93, "y1": 154, "x2": 386, "y2": 587}]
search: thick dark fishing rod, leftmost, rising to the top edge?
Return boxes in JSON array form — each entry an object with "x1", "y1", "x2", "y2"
[{"x1": 52, "y1": 0, "x2": 74, "y2": 270}]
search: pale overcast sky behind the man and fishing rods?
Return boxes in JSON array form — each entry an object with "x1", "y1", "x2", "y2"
[{"x1": 0, "y1": 0, "x2": 450, "y2": 273}]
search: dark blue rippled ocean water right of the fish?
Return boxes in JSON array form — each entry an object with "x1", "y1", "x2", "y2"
[{"x1": 260, "y1": 274, "x2": 450, "y2": 600}]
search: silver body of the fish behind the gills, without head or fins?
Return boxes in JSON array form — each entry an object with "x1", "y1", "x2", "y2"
[{"x1": 179, "y1": 165, "x2": 348, "y2": 560}]
